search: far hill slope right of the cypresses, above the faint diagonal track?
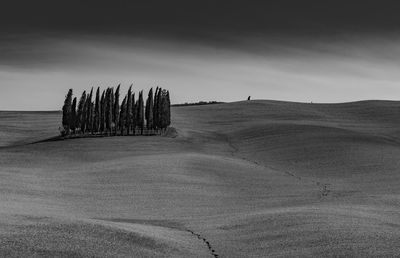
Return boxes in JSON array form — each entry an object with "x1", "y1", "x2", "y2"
[{"x1": 175, "y1": 101, "x2": 400, "y2": 190}]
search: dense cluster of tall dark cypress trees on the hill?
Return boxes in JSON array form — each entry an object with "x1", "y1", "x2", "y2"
[{"x1": 62, "y1": 85, "x2": 171, "y2": 135}]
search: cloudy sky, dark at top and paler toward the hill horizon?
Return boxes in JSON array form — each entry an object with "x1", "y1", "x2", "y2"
[{"x1": 0, "y1": 0, "x2": 400, "y2": 110}]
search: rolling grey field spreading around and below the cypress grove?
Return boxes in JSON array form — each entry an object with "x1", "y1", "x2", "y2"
[{"x1": 0, "y1": 101, "x2": 400, "y2": 257}]
